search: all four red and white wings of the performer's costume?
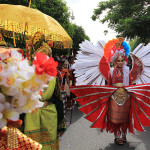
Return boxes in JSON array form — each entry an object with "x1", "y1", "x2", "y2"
[{"x1": 71, "y1": 41, "x2": 150, "y2": 133}]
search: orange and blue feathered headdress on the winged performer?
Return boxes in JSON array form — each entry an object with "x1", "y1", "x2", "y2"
[{"x1": 104, "y1": 37, "x2": 130, "y2": 63}]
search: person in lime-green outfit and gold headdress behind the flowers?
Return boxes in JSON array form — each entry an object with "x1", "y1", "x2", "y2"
[{"x1": 24, "y1": 32, "x2": 65, "y2": 150}]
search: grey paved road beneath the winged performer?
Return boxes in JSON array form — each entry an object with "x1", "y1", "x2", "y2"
[{"x1": 60, "y1": 106, "x2": 150, "y2": 150}]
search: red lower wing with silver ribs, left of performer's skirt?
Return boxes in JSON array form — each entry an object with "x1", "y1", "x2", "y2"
[{"x1": 70, "y1": 85, "x2": 117, "y2": 129}]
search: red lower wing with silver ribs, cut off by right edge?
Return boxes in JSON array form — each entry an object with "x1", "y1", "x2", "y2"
[{"x1": 126, "y1": 84, "x2": 150, "y2": 133}]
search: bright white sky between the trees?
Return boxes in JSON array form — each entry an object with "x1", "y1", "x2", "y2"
[{"x1": 65, "y1": 0, "x2": 116, "y2": 44}]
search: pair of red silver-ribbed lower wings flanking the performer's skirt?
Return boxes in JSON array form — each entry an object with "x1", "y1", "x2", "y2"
[{"x1": 71, "y1": 84, "x2": 150, "y2": 133}]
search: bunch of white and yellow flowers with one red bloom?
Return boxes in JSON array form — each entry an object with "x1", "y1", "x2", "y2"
[{"x1": 0, "y1": 50, "x2": 58, "y2": 129}]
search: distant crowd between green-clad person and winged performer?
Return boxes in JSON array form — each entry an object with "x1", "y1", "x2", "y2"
[{"x1": 57, "y1": 55, "x2": 76, "y2": 110}]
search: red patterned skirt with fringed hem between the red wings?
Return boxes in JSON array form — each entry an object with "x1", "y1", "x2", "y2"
[{"x1": 107, "y1": 98, "x2": 130, "y2": 137}]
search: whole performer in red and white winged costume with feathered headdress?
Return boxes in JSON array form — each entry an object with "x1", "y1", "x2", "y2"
[{"x1": 71, "y1": 37, "x2": 150, "y2": 145}]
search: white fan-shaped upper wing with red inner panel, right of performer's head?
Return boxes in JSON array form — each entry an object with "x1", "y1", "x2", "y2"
[{"x1": 130, "y1": 43, "x2": 150, "y2": 84}]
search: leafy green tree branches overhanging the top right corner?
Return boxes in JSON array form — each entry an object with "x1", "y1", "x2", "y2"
[{"x1": 92, "y1": 0, "x2": 150, "y2": 42}]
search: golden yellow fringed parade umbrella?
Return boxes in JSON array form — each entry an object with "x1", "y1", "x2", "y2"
[{"x1": 0, "y1": 4, "x2": 72, "y2": 48}]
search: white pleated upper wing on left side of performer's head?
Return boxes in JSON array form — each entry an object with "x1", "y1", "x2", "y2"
[{"x1": 73, "y1": 40, "x2": 109, "y2": 85}]
